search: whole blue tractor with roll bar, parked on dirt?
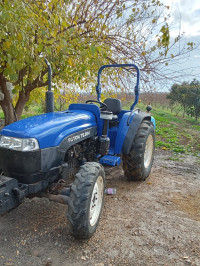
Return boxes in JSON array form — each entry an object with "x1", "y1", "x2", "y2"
[{"x1": 0, "y1": 64, "x2": 155, "y2": 239}]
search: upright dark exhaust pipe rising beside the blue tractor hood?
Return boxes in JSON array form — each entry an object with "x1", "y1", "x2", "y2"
[{"x1": 45, "y1": 58, "x2": 54, "y2": 113}]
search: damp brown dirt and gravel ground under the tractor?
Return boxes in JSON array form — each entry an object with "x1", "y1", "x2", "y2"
[{"x1": 0, "y1": 150, "x2": 200, "y2": 266}]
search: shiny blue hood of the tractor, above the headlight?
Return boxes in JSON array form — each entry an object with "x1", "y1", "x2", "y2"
[{"x1": 0, "y1": 110, "x2": 97, "y2": 149}]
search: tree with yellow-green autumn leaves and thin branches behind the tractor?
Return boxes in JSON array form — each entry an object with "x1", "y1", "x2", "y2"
[{"x1": 0, "y1": 0, "x2": 195, "y2": 124}]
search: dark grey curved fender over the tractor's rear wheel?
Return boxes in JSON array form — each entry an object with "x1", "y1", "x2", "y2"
[{"x1": 122, "y1": 112, "x2": 151, "y2": 154}]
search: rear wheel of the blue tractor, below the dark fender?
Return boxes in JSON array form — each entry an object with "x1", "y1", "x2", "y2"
[{"x1": 123, "y1": 120, "x2": 155, "y2": 181}]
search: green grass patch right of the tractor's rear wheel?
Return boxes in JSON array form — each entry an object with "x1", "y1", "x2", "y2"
[{"x1": 152, "y1": 107, "x2": 200, "y2": 157}]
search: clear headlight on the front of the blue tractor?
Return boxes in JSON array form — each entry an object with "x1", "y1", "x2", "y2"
[{"x1": 0, "y1": 136, "x2": 39, "y2": 151}]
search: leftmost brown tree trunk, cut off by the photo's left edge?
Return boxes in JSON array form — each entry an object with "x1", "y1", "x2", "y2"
[{"x1": 0, "y1": 73, "x2": 16, "y2": 126}]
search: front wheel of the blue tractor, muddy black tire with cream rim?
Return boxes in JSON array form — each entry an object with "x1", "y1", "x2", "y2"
[{"x1": 67, "y1": 162, "x2": 105, "y2": 239}]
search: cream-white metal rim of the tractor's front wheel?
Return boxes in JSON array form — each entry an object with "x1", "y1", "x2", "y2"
[{"x1": 89, "y1": 176, "x2": 104, "y2": 226}]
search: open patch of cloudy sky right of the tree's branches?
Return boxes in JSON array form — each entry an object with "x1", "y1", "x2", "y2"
[{"x1": 162, "y1": 0, "x2": 200, "y2": 89}]
